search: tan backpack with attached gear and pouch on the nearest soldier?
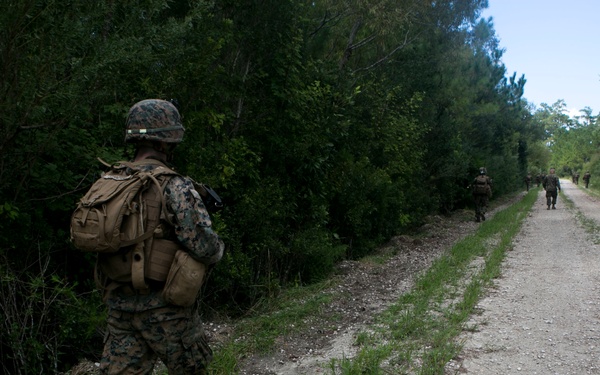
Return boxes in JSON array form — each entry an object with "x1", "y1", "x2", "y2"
[{"x1": 71, "y1": 160, "x2": 222, "y2": 306}]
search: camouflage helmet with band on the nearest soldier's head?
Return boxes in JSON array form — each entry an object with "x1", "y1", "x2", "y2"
[{"x1": 125, "y1": 99, "x2": 185, "y2": 143}]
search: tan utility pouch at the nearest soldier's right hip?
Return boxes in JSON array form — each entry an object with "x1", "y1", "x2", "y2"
[{"x1": 163, "y1": 250, "x2": 206, "y2": 307}]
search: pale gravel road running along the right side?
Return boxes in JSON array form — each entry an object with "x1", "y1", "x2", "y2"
[{"x1": 446, "y1": 180, "x2": 600, "y2": 375}]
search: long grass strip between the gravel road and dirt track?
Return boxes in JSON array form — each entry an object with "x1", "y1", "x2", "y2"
[{"x1": 329, "y1": 190, "x2": 538, "y2": 375}]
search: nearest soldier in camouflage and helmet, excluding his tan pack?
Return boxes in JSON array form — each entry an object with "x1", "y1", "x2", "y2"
[{"x1": 99, "y1": 99, "x2": 223, "y2": 375}]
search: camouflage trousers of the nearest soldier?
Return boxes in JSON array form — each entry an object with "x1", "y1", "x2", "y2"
[{"x1": 100, "y1": 306, "x2": 212, "y2": 375}]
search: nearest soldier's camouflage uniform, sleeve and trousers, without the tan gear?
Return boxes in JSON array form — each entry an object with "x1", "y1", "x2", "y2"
[{"x1": 100, "y1": 164, "x2": 223, "y2": 374}]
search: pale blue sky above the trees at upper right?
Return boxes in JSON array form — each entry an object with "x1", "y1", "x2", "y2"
[{"x1": 482, "y1": 0, "x2": 600, "y2": 116}]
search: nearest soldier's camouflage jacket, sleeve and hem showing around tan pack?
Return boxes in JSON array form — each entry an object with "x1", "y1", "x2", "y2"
[{"x1": 106, "y1": 163, "x2": 224, "y2": 312}]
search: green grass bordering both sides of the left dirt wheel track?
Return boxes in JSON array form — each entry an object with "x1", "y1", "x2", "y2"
[{"x1": 210, "y1": 189, "x2": 538, "y2": 375}]
